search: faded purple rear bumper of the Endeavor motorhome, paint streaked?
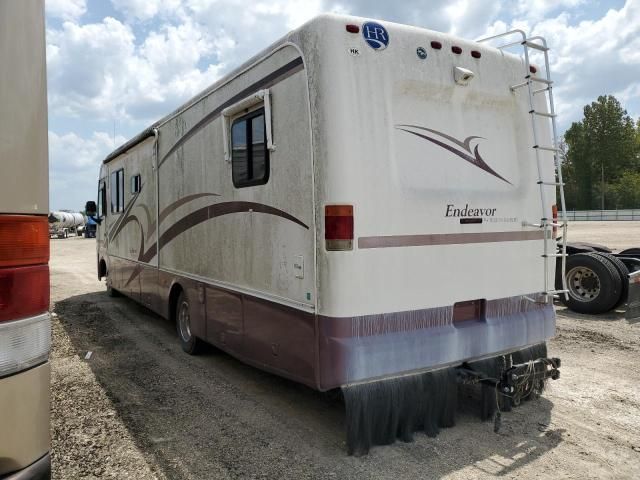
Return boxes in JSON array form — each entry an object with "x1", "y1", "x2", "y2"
[{"x1": 318, "y1": 295, "x2": 555, "y2": 390}]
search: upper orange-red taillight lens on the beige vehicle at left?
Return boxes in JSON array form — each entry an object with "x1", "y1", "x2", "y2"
[{"x1": 0, "y1": 215, "x2": 49, "y2": 268}]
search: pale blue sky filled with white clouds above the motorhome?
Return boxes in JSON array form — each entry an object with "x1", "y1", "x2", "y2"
[{"x1": 45, "y1": 0, "x2": 640, "y2": 210}]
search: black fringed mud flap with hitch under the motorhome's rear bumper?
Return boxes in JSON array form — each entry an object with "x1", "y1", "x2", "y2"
[{"x1": 342, "y1": 344, "x2": 560, "y2": 455}]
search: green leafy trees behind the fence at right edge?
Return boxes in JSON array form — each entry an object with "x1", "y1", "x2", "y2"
[{"x1": 560, "y1": 95, "x2": 640, "y2": 210}]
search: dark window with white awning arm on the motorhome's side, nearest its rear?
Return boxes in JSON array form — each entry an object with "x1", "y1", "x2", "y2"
[{"x1": 231, "y1": 108, "x2": 269, "y2": 188}]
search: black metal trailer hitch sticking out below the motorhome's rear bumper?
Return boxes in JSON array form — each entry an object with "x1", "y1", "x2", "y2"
[{"x1": 456, "y1": 355, "x2": 561, "y2": 433}]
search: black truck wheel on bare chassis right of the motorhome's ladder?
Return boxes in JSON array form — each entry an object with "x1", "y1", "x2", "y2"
[{"x1": 560, "y1": 253, "x2": 622, "y2": 313}]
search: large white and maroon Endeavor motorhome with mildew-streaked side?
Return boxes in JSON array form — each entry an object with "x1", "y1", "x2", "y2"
[{"x1": 88, "y1": 15, "x2": 558, "y2": 452}]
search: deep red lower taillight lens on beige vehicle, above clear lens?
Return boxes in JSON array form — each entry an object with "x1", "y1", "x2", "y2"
[{"x1": 0, "y1": 265, "x2": 49, "y2": 322}]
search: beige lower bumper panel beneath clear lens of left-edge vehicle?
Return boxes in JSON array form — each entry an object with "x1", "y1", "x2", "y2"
[{"x1": 0, "y1": 362, "x2": 50, "y2": 480}]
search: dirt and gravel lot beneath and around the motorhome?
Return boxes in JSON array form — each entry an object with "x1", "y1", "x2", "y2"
[{"x1": 51, "y1": 222, "x2": 640, "y2": 480}]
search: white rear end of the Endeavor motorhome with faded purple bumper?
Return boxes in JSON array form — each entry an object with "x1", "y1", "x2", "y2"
[{"x1": 303, "y1": 16, "x2": 555, "y2": 389}]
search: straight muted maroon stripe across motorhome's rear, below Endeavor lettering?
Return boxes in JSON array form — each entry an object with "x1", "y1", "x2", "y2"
[{"x1": 358, "y1": 230, "x2": 544, "y2": 248}]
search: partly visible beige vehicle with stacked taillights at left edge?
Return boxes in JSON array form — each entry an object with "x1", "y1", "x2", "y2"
[{"x1": 0, "y1": 0, "x2": 51, "y2": 480}]
